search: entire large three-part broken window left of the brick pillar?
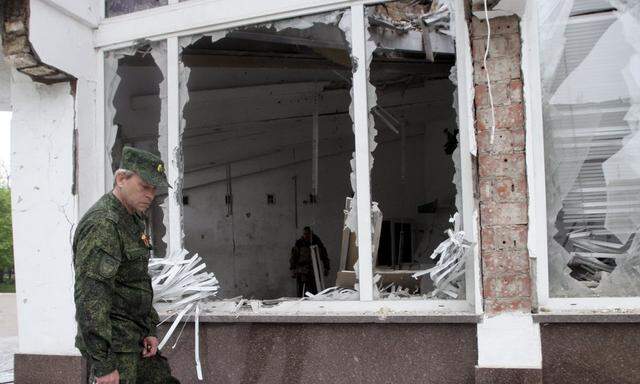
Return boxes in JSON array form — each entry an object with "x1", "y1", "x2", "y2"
[{"x1": 105, "y1": 1, "x2": 470, "y2": 310}]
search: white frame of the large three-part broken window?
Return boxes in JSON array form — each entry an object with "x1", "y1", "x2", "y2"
[{"x1": 95, "y1": 0, "x2": 482, "y2": 317}]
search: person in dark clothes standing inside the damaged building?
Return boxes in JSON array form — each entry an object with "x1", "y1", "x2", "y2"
[{"x1": 289, "y1": 227, "x2": 330, "y2": 297}]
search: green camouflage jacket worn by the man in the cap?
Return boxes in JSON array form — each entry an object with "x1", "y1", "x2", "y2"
[{"x1": 73, "y1": 193, "x2": 158, "y2": 376}]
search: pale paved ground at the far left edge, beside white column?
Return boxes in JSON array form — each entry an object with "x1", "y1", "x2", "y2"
[{"x1": 0, "y1": 293, "x2": 18, "y2": 384}]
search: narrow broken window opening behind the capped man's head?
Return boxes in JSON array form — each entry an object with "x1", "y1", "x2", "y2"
[{"x1": 105, "y1": 41, "x2": 167, "y2": 256}]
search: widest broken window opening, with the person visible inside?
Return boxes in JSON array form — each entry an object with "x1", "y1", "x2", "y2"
[{"x1": 180, "y1": 12, "x2": 357, "y2": 299}]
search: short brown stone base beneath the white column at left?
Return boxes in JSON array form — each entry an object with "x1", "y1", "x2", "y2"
[{"x1": 13, "y1": 353, "x2": 87, "y2": 384}]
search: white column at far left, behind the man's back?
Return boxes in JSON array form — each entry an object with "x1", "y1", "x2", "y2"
[{"x1": 11, "y1": 71, "x2": 77, "y2": 355}]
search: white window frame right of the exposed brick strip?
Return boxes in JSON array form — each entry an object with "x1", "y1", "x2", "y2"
[{"x1": 522, "y1": 1, "x2": 640, "y2": 312}]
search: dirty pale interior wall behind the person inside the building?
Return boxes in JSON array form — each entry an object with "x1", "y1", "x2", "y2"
[{"x1": 184, "y1": 154, "x2": 351, "y2": 298}]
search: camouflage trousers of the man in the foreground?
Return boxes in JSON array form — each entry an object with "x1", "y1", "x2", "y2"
[{"x1": 89, "y1": 352, "x2": 180, "y2": 384}]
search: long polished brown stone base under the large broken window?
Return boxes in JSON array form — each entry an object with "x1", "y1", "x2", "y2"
[{"x1": 164, "y1": 323, "x2": 478, "y2": 384}]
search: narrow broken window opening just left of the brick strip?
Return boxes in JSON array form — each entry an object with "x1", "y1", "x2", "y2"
[{"x1": 367, "y1": 1, "x2": 468, "y2": 300}]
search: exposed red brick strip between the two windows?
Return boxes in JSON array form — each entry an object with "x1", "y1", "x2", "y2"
[{"x1": 471, "y1": 16, "x2": 532, "y2": 315}]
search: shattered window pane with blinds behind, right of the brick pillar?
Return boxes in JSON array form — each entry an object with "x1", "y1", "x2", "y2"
[{"x1": 538, "y1": 0, "x2": 640, "y2": 297}]
